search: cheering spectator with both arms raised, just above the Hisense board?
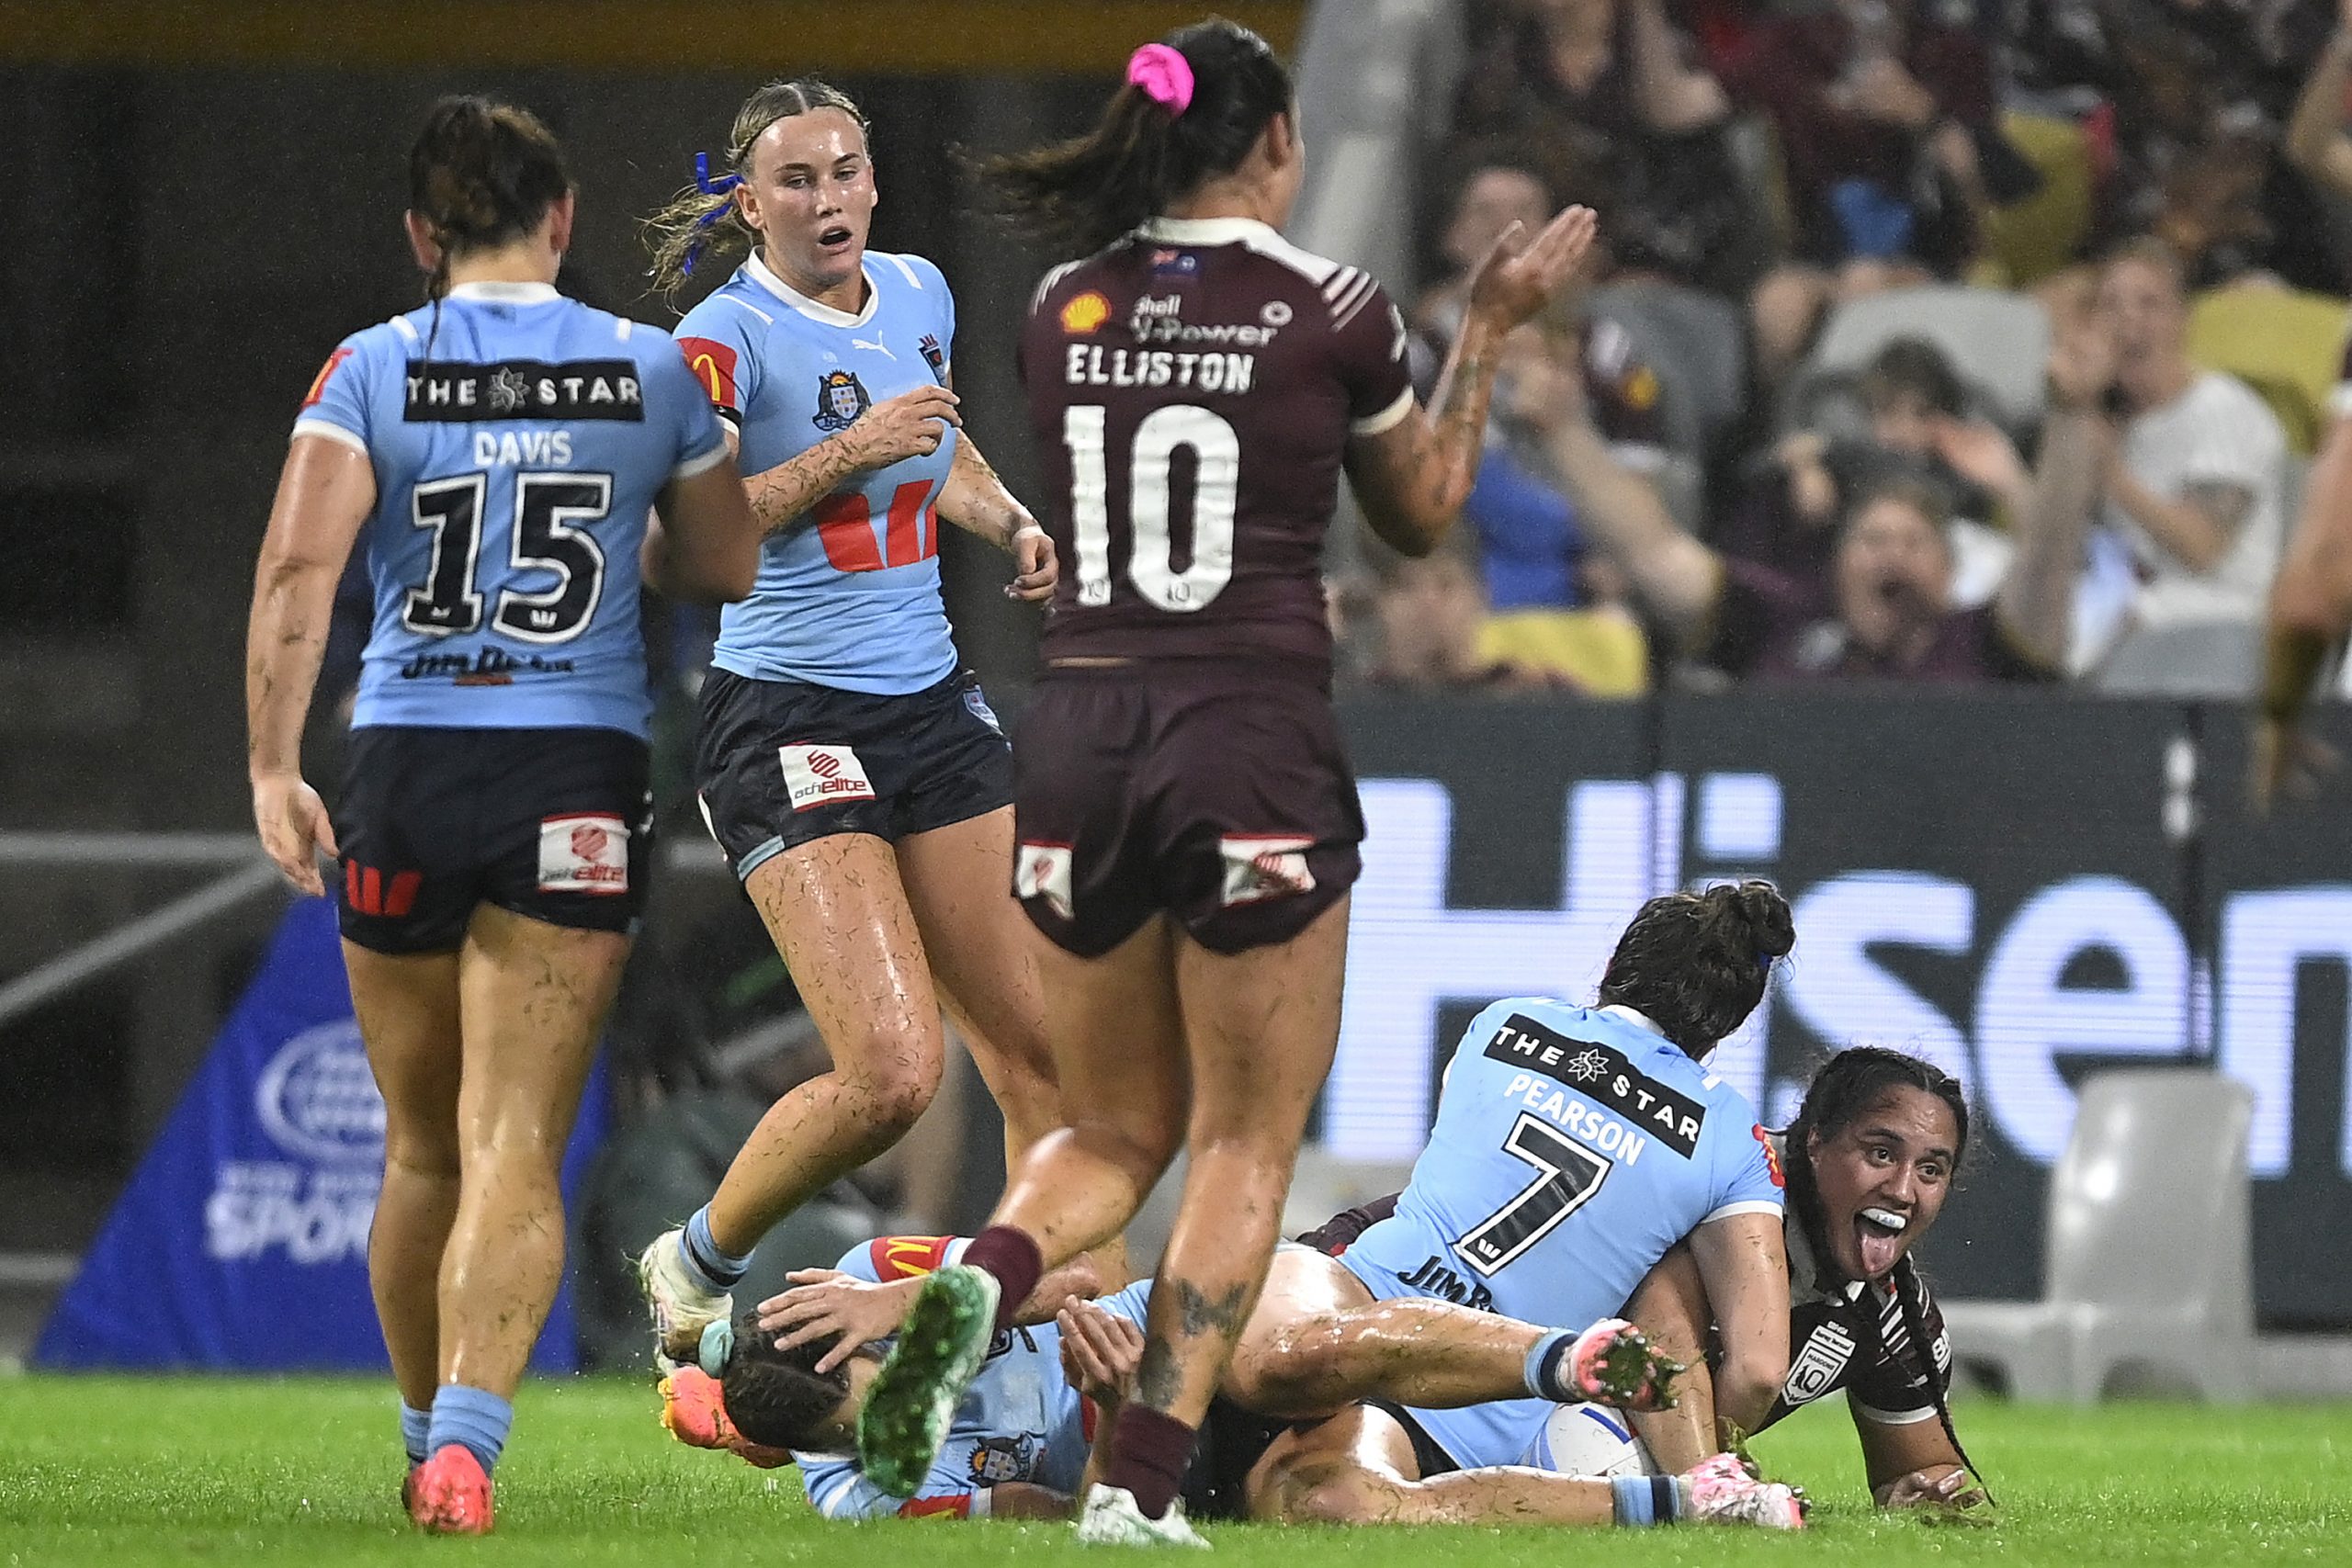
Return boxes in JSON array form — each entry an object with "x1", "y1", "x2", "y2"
[{"x1": 1547, "y1": 333, "x2": 2112, "y2": 682}]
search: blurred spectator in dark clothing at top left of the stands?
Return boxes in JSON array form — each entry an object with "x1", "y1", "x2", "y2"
[{"x1": 1456, "y1": 0, "x2": 1771, "y2": 296}]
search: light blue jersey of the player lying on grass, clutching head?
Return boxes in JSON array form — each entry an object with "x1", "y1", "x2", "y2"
[{"x1": 793, "y1": 1236, "x2": 1152, "y2": 1518}]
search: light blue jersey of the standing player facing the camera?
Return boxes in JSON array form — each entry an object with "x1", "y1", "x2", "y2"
[{"x1": 677, "y1": 252, "x2": 957, "y2": 696}]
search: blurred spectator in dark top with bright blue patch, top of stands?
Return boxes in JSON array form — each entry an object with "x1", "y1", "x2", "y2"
[{"x1": 1729, "y1": 0, "x2": 2004, "y2": 383}]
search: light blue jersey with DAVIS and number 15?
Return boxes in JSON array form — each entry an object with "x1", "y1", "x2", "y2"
[{"x1": 294, "y1": 282, "x2": 727, "y2": 739}]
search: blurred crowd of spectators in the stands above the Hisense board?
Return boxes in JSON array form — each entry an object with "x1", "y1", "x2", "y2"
[{"x1": 1334, "y1": 0, "x2": 2352, "y2": 696}]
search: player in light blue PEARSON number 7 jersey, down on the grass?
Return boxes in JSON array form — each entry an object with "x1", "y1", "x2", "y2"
[{"x1": 1226, "y1": 882, "x2": 1792, "y2": 1517}]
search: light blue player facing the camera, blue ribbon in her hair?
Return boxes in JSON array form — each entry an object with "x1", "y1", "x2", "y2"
[{"x1": 639, "y1": 83, "x2": 1061, "y2": 1392}]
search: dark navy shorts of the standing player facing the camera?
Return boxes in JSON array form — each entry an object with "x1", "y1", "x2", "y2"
[{"x1": 694, "y1": 670, "x2": 1013, "y2": 877}]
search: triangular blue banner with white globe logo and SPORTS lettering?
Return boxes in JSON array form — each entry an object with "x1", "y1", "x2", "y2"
[{"x1": 33, "y1": 898, "x2": 606, "y2": 1373}]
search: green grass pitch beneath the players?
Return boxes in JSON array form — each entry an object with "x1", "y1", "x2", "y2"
[{"x1": 0, "y1": 1378, "x2": 2352, "y2": 1568}]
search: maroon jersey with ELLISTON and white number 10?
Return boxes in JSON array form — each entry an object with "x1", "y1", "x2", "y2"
[{"x1": 1018, "y1": 219, "x2": 1414, "y2": 672}]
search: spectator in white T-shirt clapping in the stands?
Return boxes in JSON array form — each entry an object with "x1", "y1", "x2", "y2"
[{"x1": 2041, "y1": 240, "x2": 2286, "y2": 659}]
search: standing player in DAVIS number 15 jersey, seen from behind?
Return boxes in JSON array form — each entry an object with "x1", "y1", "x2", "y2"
[{"x1": 247, "y1": 98, "x2": 755, "y2": 1533}]
